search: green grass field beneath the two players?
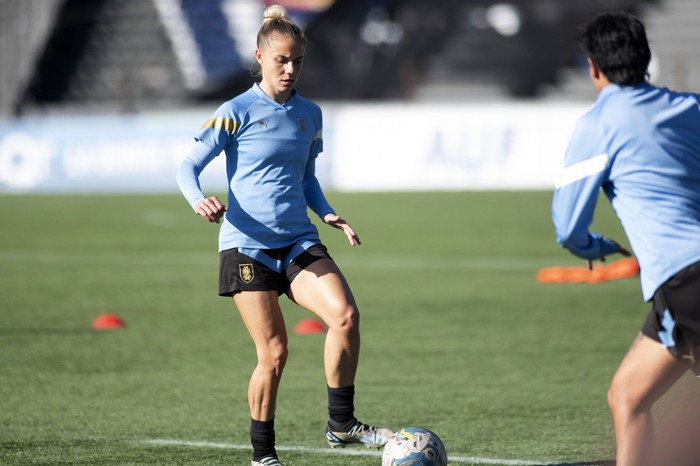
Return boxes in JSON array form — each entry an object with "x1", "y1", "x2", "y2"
[{"x1": 0, "y1": 192, "x2": 696, "y2": 466}]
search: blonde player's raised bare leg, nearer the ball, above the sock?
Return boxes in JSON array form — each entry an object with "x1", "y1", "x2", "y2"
[{"x1": 289, "y1": 259, "x2": 360, "y2": 388}]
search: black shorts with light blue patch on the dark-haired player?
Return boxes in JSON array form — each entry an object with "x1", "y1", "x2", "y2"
[{"x1": 642, "y1": 262, "x2": 700, "y2": 375}]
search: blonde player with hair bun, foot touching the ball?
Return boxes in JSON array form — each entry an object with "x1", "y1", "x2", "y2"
[{"x1": 177, "y1": 5, "x2": 393, "y2": 466}]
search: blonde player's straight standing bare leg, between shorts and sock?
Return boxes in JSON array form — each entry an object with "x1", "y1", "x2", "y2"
[{"x1": 233, "y1": 291, "x2": 287, "y2": 421}]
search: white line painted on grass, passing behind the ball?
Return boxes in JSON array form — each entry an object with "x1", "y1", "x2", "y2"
[{"x1": 144, "y1": 439, "x2": 547, "y2": 466}]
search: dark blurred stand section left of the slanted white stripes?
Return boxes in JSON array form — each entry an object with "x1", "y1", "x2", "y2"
[{"x1": 23, "y1": 0, "x2": 187, "y2": 112}]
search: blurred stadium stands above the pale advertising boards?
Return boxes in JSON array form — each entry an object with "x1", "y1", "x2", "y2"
[{"x1": 5, "y1": 0, "x2": 700, "y2": 116}]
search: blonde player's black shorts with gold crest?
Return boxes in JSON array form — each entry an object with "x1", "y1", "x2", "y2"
[{"x1": 219, "y1": 244, "x2": 333, "y2": 296}]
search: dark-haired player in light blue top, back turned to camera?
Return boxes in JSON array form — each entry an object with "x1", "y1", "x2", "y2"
[{"x1": 552, "y1": 12, "x2": 700, "y2": 466}]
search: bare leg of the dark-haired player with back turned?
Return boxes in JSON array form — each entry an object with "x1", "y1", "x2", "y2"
[{"x1": 608, "y1": 335, "x2": 689, "y2": 466}]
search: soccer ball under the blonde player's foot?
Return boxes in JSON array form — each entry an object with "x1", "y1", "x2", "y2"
[{"x1": 382, "y1": 427, "x2": 447, "y2": 466}]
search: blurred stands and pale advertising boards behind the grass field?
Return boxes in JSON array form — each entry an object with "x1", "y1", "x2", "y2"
[{"x1": 0, "y1": 0, "x2": 700, "y2": 193}]
